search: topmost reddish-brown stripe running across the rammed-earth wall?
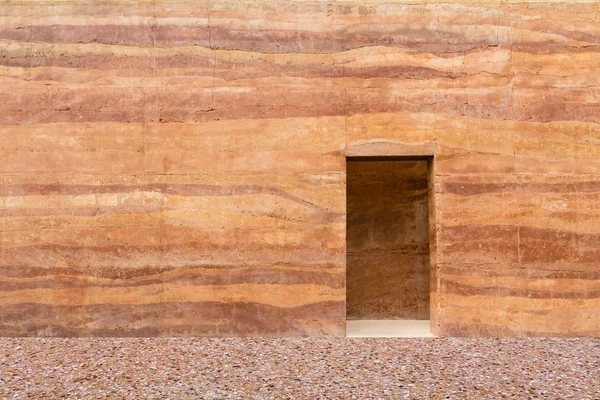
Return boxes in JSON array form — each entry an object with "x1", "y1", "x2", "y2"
[{"x1": 0, "y1": 31, "x2": 600, "y2": 57}]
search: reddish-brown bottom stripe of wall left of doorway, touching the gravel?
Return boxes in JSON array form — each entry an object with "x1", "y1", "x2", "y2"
[{"x1": 0, "y1": 301, "x2": 345, "y2": 337}]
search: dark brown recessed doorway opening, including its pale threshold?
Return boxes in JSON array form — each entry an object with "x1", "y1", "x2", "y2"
[{"x1": 346, "y1": 157, "x2": 432, "y2": 337}]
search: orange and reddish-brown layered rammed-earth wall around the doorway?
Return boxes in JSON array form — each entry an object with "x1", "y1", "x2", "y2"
[{"x1": 0, "y1": 0, "x2": 600, "y2": 336}]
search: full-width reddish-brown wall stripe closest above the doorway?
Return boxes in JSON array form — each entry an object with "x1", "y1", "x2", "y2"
[{"x1": 0, "y1": 94, "x2": 600, "y2": 125}]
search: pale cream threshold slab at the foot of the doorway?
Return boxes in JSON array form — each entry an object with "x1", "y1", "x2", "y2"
[{"x1": 346, "y1": 320, "x2": 434, "y2": 337}]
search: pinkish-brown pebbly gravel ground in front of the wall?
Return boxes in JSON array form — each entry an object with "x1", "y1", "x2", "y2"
[{"x1": 0, "y1": 339, "x2": 600, "y2": 399}]
